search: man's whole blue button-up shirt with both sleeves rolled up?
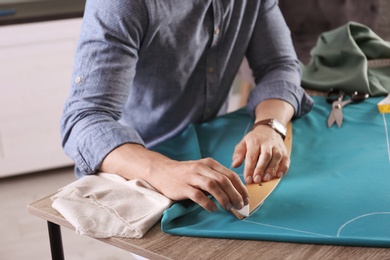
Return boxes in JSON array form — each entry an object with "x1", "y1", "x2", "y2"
[{"x1": 61, "y1": 0, "x2": 312, "y2": 175}]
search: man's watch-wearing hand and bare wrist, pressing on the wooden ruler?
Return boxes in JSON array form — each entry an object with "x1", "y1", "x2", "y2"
[{"x1": 232, "y1": 99, "x2": 294, "y2": 184}]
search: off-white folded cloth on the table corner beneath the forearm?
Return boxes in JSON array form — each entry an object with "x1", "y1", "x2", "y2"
[{"x1": 51, "y1": 173, "x2": 172, "y2": 238}]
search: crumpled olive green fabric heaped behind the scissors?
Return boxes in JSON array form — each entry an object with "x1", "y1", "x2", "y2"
[{"x1": 301, "y1": 22, "x2": 390, "y2": 96}]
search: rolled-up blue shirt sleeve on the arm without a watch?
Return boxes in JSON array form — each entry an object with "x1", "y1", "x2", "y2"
[{"x1": 61, "y1": 0, "x2": 147, "y2": 175}]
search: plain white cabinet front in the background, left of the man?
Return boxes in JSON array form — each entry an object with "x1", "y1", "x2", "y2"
[{"x1": 0, "y1": 18, "x2": 81, "y2": 177}]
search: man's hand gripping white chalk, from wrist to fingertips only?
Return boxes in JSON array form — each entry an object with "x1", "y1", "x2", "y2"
[{"x1": 150, "y1": 158, "x2": 249, "y2": 212}]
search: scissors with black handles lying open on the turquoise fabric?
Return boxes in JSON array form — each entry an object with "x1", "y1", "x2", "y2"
[{"x1": 326, "y1": 89, "x2": 369, "y2": 127}]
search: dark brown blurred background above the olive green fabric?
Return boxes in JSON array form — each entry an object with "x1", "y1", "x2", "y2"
[{"x1": 279, "y1": 0, "x2": 390, "y2": 63}]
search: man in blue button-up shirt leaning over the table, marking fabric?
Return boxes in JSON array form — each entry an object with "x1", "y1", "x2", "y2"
[{"x1": 61, "y1": 0, "x2": 312, "y2": 211}]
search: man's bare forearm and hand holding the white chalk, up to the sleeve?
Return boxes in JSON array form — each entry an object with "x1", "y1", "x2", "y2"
[{"x1": 100, "y1": 144, "x2": 249, "y2": 212}]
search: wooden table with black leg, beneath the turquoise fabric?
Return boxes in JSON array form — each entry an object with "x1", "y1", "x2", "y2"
[{"x1": 27, "y1": 196, "x2": 390, "y2": 260}]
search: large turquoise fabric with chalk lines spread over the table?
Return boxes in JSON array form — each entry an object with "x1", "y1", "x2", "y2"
[{"x1": 155, "y1": 97, "x2": 390, "y2": 247}]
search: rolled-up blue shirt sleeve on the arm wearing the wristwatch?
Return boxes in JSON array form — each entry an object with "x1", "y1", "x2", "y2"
[{"x1": 246, "y1": 0, "x2": 313, "y2": 117}]
